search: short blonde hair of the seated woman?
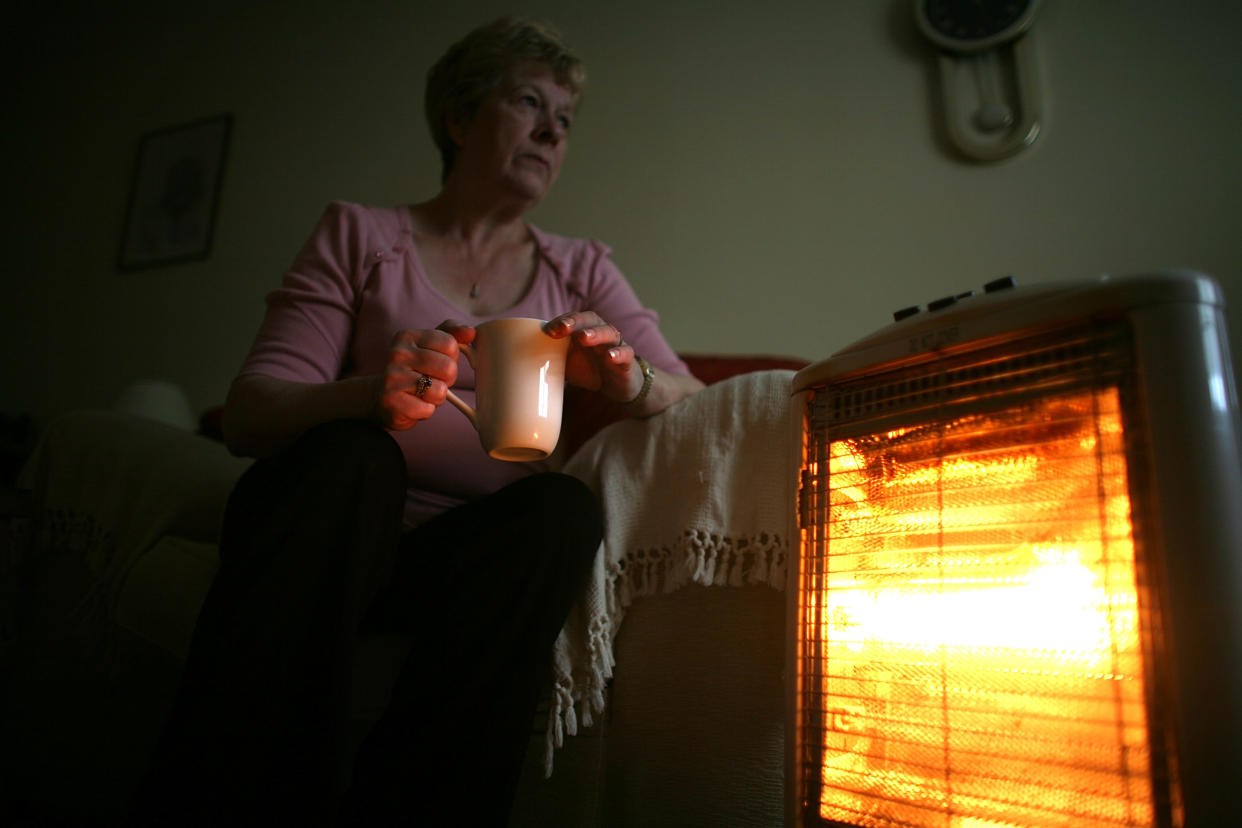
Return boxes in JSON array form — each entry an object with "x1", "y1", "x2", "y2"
[{"x1": 424, "y1": 17, "x2": 586, "y2": 181}]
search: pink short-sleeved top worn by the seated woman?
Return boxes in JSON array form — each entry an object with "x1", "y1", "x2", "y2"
[{"x1": 241, "y1": 202, "x2": 689, "y2": 525}]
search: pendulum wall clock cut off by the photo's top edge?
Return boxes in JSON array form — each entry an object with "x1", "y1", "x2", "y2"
[{"x1": 914, "y1": 0, "x2": 1042, "y2": 161}]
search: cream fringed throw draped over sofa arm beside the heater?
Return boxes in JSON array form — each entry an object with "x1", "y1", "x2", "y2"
[{"x1": 544, "y1": 371, "x2": 800, "y2": 775}]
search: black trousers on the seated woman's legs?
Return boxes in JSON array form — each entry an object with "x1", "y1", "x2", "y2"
[{"x1": 132, "y1": 421, "x2": 602, "y2": 826}]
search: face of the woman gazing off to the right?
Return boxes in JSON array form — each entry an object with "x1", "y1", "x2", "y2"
[{"x1": 450, "y1": 61, "x2": 574, "y2": 204}]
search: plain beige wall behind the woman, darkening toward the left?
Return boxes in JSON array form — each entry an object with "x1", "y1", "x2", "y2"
[{"x1": 9, "y1": 0, "x2": 1242, "y2": 418}]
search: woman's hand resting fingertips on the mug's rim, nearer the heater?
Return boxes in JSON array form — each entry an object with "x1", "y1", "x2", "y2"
[{"x1": 544, "y1": 310, "x2": 643, "y2": 402}]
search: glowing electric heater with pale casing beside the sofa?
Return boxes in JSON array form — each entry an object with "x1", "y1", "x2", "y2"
[{"x1": 786, "y1": 272, "x2": 1242, "y2": 828}]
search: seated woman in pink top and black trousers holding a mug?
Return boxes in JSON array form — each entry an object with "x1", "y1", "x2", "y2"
[{"x1": 134, "y1": 19, "x2": 702, "y2": 826}]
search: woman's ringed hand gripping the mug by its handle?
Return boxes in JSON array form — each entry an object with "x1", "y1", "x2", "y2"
[{"x1": 375, "y1": 319, "x2": 474, "y2": 431}]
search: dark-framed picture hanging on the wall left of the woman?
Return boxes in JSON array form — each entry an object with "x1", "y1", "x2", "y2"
[{"x1": 118, "y1": 114, "x2": 232, "y2": 271}]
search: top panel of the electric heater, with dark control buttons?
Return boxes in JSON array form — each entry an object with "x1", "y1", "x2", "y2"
[{"x1": 794, "y1": 271, "x2": 1225, "y2": 392}]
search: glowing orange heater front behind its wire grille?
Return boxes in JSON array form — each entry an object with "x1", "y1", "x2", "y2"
[{"x1": 799, "y1": 325, "x2": 1175, "y2": 828}]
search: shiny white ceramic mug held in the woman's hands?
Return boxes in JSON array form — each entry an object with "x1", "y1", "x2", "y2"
[{"x1": 448, "y1": 318, "x2": 569, "y2": 461}]
